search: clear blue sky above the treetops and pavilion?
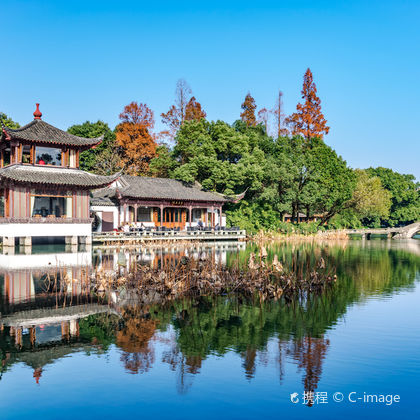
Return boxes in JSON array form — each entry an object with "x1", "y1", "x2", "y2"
[{"x1": 0, "y1": 0, "x2": 420, "y2": 180}]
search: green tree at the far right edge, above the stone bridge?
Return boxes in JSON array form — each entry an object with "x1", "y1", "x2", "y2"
[{"x1": 366, "y1": 167, "x2": 420, "y2": 226}]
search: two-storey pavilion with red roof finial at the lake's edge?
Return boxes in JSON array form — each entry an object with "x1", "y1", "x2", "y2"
[{"x1": 0, "y1": 104, "x2": 117, "y2": 247}]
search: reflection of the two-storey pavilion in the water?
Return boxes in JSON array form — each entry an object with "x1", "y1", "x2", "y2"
[{"x1": 0, "y1": 252, "x2": 115, "y2": 383}]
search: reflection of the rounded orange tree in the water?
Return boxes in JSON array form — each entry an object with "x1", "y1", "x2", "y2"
[{"x1": 116, "y1": 306, "x2": 158, "y2": 373}]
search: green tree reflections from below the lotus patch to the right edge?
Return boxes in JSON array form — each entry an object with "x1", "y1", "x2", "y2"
[{"x1": 151, "y1": 238, "x2": 420, "y2": 391}]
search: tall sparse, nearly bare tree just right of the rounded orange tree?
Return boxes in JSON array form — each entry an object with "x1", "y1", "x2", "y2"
[{"x1": 160, "y1": 79, "x2": 194, "y2": 140}]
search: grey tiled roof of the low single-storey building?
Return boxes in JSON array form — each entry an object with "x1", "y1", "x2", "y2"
[{"x1": 94, "y1": 175, "x2": 227, "y2": 205}]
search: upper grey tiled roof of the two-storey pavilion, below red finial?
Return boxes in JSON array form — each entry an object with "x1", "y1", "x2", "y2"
[{"x1": 3, "y1": 119, "x2": 103, "y2": 148}]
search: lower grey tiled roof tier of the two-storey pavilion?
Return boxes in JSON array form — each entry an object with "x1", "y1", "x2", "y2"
[{"x1": 0, "y1": 164, "x2": 120, "y2": 189}]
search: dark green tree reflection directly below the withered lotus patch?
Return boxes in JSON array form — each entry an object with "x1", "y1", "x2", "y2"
[{"x1": 157, "y1": 296, "x2": 343, "y2": 384}]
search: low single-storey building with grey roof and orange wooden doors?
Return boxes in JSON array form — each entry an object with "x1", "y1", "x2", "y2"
[{"x1": 91, "y1": 176, "x2": 227, "y2": 232}]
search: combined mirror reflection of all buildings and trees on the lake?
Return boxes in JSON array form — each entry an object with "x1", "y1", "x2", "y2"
[{"x1": 0, "y1": 241, "x2": 420, "y2": 394}]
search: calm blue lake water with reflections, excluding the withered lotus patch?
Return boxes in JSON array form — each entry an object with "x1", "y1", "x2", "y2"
[{"x1": 0, "y1": 239, "x2": 420, "y2": 419}]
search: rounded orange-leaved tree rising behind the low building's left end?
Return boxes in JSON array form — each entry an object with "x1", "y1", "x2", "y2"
[{"x1": 116, "y1": 102, "x2": 156, "y2": 175}]
